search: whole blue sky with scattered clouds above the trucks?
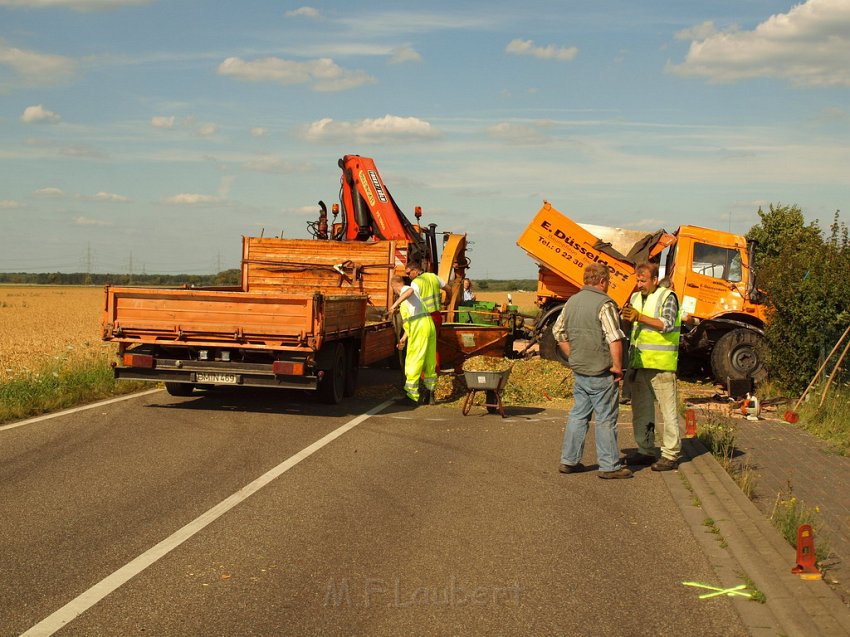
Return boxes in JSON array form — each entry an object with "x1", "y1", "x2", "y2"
[{"x1": 0, "y1": 0, "x2": 850, "y2": 278}]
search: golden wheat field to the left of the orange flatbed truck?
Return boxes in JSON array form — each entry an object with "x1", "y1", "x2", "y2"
[{"x1": 0, "y1": 286, "x2": 109, "y2": 382}]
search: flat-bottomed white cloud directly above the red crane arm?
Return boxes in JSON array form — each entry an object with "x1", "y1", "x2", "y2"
[{"x1": 303, "y1": 115, "x2": 439, "y2": 142}]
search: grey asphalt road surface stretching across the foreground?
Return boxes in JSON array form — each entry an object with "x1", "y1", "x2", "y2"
[{"x1": 0, "y1": 372, "x2": 746, "y2": 636}]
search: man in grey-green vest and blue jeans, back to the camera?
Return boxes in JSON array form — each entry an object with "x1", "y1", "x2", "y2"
[{"x1": 552, "y1": 263, "x2": 632, "y2": 479}]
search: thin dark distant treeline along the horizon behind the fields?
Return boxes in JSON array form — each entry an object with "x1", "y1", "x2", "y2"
[{"x1": 0, "y1": 269, "x2": 537, "y2": 292}]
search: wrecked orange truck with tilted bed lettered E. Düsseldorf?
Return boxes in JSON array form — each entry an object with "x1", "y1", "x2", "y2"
[{"x1": 517, "y1": 202, "x2": 767, "y2": 385}]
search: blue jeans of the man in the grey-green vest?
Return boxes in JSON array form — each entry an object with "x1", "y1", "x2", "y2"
[{"x1": 561, "y1": 373, "x2": 620, "y2": 471}]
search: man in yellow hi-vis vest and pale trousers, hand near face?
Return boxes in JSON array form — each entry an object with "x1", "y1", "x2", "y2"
[{"x1": 622, "y1": 263, "x2": 682, "y2": 471}]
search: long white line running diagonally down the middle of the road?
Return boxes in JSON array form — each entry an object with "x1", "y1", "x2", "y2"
[{"x1": 21, "y1": 400, "x2": 396, "y2": 637}]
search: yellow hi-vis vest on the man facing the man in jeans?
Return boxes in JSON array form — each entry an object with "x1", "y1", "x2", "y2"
[{"x1": 629, "y1": 287, "x2": 682, "y2": 372}]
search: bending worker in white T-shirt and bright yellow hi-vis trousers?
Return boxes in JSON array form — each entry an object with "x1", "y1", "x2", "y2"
[{"x1": 389, "y1": 276, "x2": 437, "y2": 404}]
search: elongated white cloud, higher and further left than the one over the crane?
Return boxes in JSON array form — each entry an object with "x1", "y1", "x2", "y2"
[{"x1": 218, "y1": 57, "x2": 377, "y2": 91}]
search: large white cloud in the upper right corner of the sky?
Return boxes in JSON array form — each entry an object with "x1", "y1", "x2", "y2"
[{"x1": 667, "y1": 0, "x2": 850, "y2": 86}]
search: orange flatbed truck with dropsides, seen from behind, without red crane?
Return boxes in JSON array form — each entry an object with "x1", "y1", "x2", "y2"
[{"x1": 102, "y1": 237, "x2": 407, "y2": 403}]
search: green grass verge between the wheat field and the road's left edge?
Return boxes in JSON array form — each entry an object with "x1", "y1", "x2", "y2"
[{"x1": 0, "y1": 355, "x2": 150, "y2": 424}]
